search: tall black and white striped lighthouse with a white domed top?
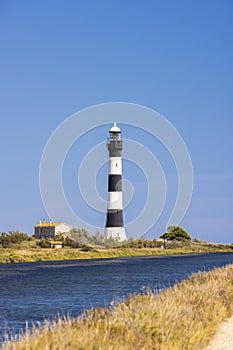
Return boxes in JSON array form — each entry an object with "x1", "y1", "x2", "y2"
[{"x1": 105, "y1": 123, "x2": 127, "y2": 241}]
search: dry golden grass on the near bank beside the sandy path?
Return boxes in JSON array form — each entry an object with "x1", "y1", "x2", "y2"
[{"x1": 4, "y1": 265, "x2": 233, "y2": 350}]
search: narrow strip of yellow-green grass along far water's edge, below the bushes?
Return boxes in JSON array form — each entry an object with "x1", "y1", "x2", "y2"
[{"x1": 0, "y1": 243, "x2": 233, "y2": 264}]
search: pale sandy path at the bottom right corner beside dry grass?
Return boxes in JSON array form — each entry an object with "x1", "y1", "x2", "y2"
[{"x1": 205, "y1": 317, "x2": 233, "y2": 350}]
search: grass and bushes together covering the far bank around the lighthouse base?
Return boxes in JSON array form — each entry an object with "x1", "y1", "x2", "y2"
[{"x1": 0, "y1": 228, "x2": 233, "y2": 263}]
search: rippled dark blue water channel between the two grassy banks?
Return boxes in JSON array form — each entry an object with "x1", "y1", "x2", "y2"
[{"x1": 0, "y1": 253, "x2": 233, "y2": 342}]
